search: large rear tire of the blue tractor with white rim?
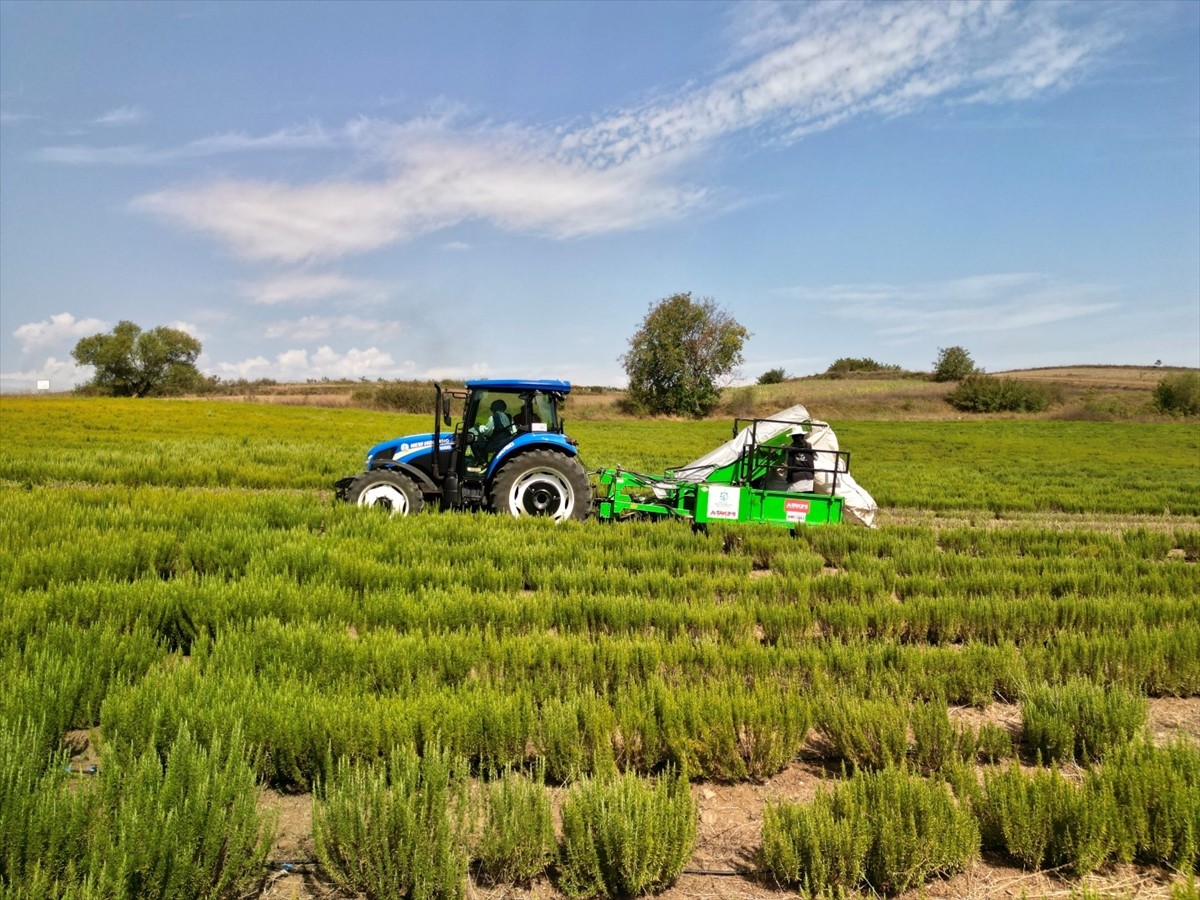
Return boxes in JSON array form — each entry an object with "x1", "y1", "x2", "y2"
[{"x1": 491, "y1": 450, "x2": 592, "y2": 522}]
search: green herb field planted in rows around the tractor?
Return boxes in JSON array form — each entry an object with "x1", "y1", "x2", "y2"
[{"x1": 0, "y1": 397, "x2": 1200, "y2": 898}]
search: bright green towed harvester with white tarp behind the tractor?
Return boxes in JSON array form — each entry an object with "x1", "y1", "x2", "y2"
[{"x1": 594, "y1": 407, "x2": 875, "y2": 532}]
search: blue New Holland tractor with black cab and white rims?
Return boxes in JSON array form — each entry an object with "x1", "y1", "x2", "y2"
[{"x1": 335, "y1": 379, "x2": 592, "y2": 521}]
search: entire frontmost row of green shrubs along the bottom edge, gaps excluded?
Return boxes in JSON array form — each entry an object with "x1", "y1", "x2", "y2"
[{"x1": 7, "y1": 719, "x2": 1200, "y2": 900}]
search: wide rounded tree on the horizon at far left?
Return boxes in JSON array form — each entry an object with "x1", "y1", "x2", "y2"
[{"x1": 71, "y1": 322, "x2": 204, "y2": 397}]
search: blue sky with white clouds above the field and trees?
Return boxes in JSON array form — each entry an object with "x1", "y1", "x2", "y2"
[{"x1": 0, "y1": 0, "x2": 1200, "y2": 390}]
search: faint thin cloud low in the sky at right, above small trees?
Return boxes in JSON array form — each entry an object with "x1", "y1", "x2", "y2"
[{"x1": 778, "y1": 272, "x2": 1121, "y2": 341}]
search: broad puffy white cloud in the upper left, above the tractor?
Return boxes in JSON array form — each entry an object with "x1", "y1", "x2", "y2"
[{"x1": 134, "y1": 121, "x2": 704, "y2": 262}]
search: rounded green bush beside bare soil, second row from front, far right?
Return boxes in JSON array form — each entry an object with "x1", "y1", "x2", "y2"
[{"x1": 1021, "y1": 678, "x2": 1146, "y2": 762}]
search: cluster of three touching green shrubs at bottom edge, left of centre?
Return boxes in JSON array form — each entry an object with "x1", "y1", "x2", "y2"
[{"x1": 313, "y1": 748, "x2": 696, "y2": 900}]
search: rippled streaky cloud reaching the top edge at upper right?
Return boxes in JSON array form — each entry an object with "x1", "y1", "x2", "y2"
[{"x1": 563, "y1": 2, "x2": 1115, "y2": 166}]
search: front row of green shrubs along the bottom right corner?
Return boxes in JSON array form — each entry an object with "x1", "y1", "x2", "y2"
[{"x1": 761, "y1": 742, "x2": 1200, "y2": 898}]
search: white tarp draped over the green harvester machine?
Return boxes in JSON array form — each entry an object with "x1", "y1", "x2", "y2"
[{"x1": 673, "y1": 403, "x2": 878, "y2": 528}]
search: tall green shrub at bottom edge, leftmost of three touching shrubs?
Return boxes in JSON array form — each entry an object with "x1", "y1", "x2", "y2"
[{"x1": 313, "y1": 748, "x2": 468, "y2": 900}]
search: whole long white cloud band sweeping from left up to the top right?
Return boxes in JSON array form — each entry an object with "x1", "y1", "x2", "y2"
[{"x1": 126, "y1": 2, "x2": 1115, "y2": 262}]
